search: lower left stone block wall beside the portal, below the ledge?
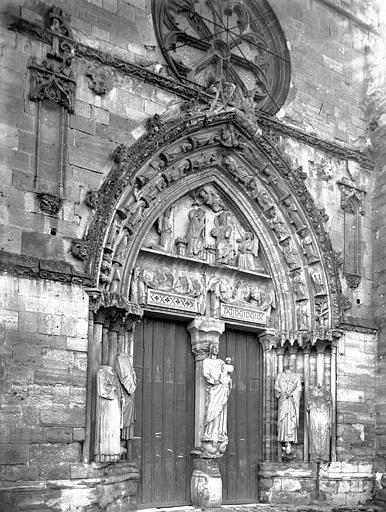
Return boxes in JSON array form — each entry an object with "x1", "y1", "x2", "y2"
[{"x1": 0, "y1": 275, "x2": 88, "y2": 487}]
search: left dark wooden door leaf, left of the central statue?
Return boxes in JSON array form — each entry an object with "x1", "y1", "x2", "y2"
[{"x1": 133, "y1": 318, "x2": 194, "y2": 508}]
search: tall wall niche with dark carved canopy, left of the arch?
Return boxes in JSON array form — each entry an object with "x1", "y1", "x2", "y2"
[{"x1": 28, "y1": 6, "x2": 75, "y2": 215}]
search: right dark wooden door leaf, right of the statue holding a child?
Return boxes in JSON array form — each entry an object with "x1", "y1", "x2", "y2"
[{"x1": 220, "y1": 330, "x2": 263, "y2": 503}]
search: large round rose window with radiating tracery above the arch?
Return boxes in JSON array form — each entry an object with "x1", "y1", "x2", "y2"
[{"x1": 152, "y1": 0, "x2": 290, "y2": 114}]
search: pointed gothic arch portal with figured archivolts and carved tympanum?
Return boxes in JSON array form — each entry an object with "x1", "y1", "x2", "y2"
[{"x1": 87, "y1": 109, "x2": 341, "y2": 506}]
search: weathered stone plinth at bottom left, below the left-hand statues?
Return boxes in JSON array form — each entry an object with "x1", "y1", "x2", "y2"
[{"x1": 0, "y1": 461, "x2": 139, "y2": 512}]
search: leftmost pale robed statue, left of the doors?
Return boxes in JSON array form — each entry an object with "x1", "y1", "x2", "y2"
[{"x1": 94, "y1": 365, "x2": 122, "y2": 462}]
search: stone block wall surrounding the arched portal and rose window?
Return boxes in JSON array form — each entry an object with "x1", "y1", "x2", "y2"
[{"x1": 0, "y1": 0, "x2": 384, "y2": 504}]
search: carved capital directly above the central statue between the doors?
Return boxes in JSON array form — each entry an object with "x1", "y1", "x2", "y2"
[{"x1": 188, "y1": 317, "x2": 225, "y2": 361}]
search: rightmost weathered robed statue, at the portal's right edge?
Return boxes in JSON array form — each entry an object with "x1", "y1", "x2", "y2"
[{"x1": 307, "y1": 384, "x2": 332, "y2": 462}]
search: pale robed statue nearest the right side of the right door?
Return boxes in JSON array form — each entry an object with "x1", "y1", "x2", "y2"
[{"x1": 275, "y1": 368, "x2": 302, "y2": 455}]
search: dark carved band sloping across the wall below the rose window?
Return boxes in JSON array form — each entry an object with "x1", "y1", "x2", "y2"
[{"x1": 10, "y1": 18, "x2": 374, "y2": 169}]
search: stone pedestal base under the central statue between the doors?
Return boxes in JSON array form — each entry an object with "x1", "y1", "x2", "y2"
[{"x1": 190, "y1": 452, "x2": 222, "y2": 510}]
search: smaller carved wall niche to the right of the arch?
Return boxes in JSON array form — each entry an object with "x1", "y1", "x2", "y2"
[{"x1": 338, "y1": 181, "x2": 366, "y2": 289}]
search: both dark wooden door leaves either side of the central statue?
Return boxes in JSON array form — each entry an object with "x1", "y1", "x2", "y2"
[{"x1": 132, "y1": 318, "x2": 262, "y2": 508}]
